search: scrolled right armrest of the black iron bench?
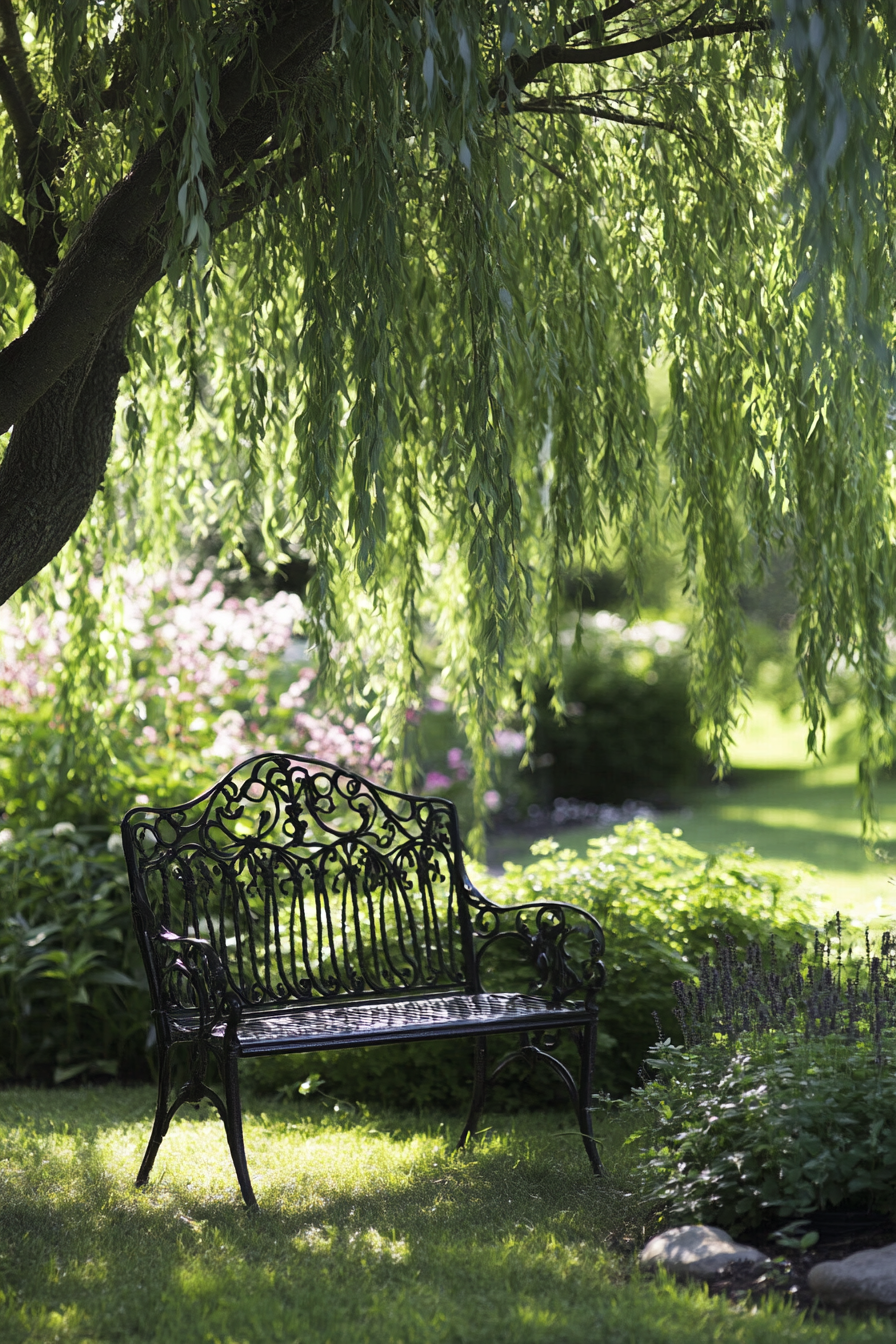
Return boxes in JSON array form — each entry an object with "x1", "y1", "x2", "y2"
[{"x1": 466, "y1": 886, "x2": 606, "y2": 1007}]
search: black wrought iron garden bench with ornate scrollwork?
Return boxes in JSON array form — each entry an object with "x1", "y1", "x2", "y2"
[{"x1": 121, "y1": 753, "x2": 603, "y2": 1208}]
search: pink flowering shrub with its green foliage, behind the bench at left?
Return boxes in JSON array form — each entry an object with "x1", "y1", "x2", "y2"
[{"x1": 0, "y1": 566, "x2": 391, "y2": 824}]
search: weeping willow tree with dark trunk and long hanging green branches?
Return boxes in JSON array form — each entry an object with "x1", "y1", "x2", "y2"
[{"x1": 0, "y1": 0, "x2": 896, "y2": 833}]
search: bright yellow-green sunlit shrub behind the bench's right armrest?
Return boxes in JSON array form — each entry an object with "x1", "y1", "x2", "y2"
[{"x1": 484, "y1": 821, "x2": 814, "y2": 1094}]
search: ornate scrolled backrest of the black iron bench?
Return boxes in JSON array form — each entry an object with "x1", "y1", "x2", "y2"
[{"x1": 121, "y1": 753, "x2": 476, "y2": 1008}]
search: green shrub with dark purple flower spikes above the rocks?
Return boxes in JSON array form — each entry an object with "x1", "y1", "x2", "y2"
[{"x1": 627, "y1": 919, "x2": 896, "y2": 1231}]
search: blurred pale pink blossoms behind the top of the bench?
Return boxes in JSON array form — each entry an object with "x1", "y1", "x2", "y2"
[{"x1": 0, "y1": 563, "x2": 392, "y2": 781}]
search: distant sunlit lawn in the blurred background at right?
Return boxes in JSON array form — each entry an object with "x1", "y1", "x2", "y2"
[{"x1": 489, "y1": 706, "x2": 896, "y2": 922}]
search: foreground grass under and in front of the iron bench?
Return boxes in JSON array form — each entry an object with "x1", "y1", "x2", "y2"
[{"x1": 0, "y1": 1086, "x2": 896, "y2": 1344}]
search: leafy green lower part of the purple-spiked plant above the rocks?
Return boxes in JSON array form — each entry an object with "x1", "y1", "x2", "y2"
[{"x1": 629, "y1": 1031, "x2": 896, "y2": 1232}]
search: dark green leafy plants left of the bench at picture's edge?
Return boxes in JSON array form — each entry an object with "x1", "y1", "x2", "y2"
[{"x1": 0, "y1": 821, "x2": 148, "y2": 1083}]
